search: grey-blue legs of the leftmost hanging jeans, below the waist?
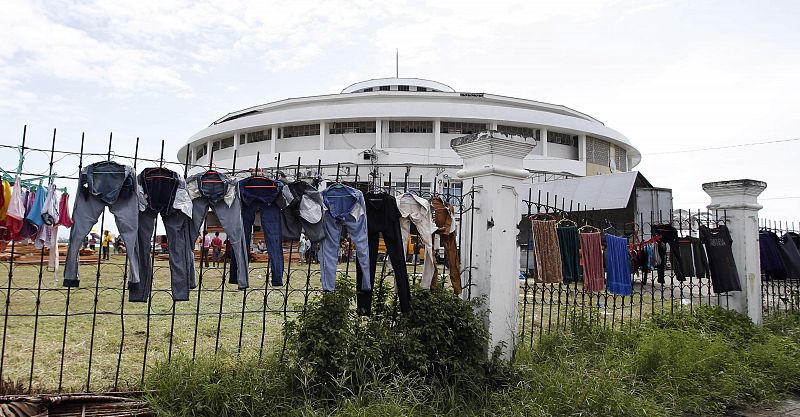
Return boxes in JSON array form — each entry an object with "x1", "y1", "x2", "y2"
[{"x1": 64, "y1": 192, "x2": 139, "y2": 288}]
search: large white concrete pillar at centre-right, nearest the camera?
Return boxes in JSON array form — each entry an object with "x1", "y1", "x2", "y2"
[{"x1": 450, "y1": 132, "x2": 535, "y2": 359}]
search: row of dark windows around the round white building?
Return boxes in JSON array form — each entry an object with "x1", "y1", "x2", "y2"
[{"x1": 195, "y1": 120, "x2": 584, "y2": 159}]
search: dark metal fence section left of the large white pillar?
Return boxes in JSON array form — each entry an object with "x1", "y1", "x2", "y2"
[{"x1": 0, "y1": 131, "x2": 472, "y2": 392}]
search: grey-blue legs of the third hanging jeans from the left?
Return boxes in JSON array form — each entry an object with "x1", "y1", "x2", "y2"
[{"x1": 190, "y1": 197, "x2": 250, "y2": 290}]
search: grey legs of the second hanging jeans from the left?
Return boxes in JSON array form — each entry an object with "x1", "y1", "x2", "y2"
[{"x1": 128, "y1": 210, "x2": 197, "y2": 302}]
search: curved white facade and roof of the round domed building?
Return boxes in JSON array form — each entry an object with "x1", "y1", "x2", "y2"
[{"x1": 178, "y1": 78, "x2": 641, "y2": 185}]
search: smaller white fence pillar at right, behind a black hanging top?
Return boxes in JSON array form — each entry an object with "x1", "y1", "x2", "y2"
[{"x1": 703, "y1": 180, "x2": 767, "y2": 324}]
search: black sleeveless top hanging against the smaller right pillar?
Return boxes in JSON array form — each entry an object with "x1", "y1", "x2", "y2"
[{"x1": 700, "y1": 225, "x2": 742, "y2": 294}]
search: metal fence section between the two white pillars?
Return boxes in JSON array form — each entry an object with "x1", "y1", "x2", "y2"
[{"x1": 520, "y1": 191, "x2": 729, "y2": 346}]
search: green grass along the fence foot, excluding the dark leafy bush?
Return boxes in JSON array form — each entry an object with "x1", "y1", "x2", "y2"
[{"x1": 147, "y1": 307, "x2": 800, "y2": 416}]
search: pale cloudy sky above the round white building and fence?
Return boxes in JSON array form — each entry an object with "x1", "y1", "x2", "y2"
[{"x1": 0, "y1": 0, "x2": 800, "y2": 227}]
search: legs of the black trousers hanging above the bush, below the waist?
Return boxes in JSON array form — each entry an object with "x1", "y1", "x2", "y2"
[{"x1": 356, "y1": 219, "x2": 411, "y2": 316}]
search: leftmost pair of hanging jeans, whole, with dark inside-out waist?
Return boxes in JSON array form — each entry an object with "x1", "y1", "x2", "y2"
[{"x1": 64, "y1": 162, "x2": 140, "y2": 290}]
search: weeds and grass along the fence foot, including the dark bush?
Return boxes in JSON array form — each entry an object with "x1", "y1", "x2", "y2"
[{"x1": 146, "y1": 291, "x2": 800, "y2": 416}]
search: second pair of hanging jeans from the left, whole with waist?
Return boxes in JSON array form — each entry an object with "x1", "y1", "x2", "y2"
[{"x1": 128, "y1": 168, "x2": 197, "y2": 302}]
